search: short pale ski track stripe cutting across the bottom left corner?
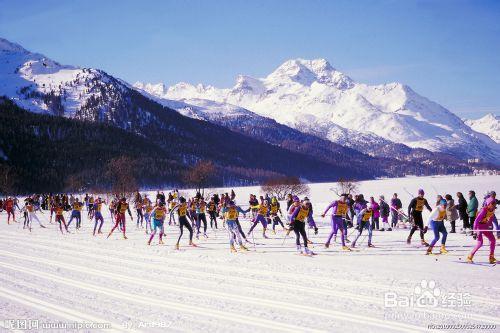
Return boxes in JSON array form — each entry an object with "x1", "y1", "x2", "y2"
[{"x1": 0, "y1": 287, "x2": 135, "y2": 332}]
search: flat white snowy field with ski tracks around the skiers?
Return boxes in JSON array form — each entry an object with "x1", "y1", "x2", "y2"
[{"x1": 0, "y1": 176, "x2": 500, "y2": 332}]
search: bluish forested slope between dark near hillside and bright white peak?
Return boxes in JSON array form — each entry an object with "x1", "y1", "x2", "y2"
[{"x1": 133, "y1": 89, "x2": 470, "y2": 176}]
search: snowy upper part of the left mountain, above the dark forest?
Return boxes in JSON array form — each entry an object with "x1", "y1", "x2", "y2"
[{"x1": 0, "y1": 38, "x2": 131, "y2": 118}]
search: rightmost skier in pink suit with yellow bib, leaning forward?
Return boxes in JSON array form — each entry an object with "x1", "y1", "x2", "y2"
[{"x1": 467, "y1": 197, "x2": 497, "y2": 264}]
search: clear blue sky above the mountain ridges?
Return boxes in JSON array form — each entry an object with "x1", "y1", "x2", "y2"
[{"x1": 0, "y1": 0, "x2": 500, "y2": 118}]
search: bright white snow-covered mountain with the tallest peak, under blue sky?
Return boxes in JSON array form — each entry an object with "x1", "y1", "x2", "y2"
[{"x1": 136, "y1": 59, "x2": 500, "y2": 162}]
